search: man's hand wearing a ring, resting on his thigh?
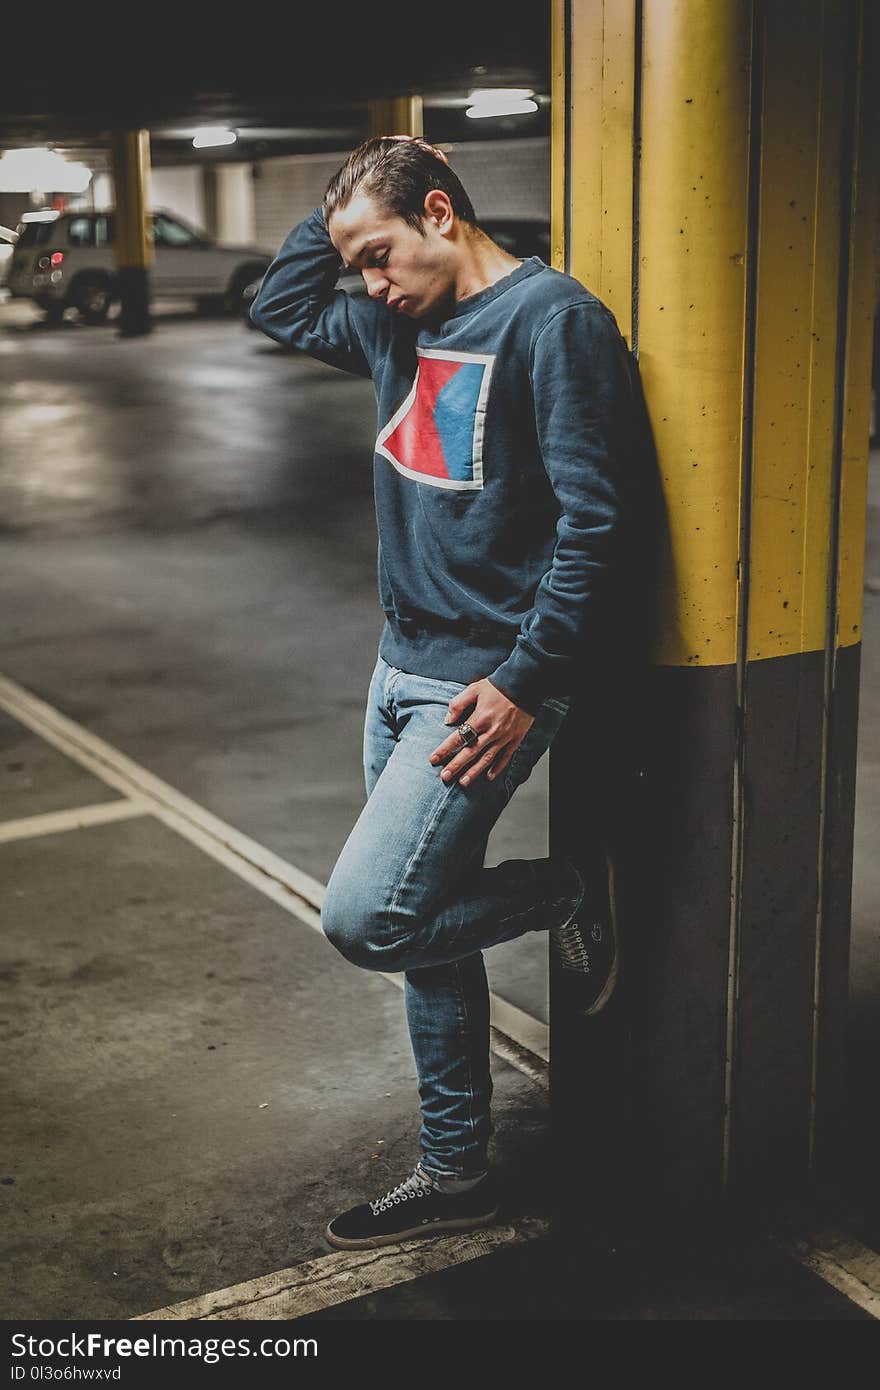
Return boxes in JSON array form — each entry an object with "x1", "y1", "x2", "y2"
[{"x1": 430, "y1": 676, "x2": 535, "y2": 787}]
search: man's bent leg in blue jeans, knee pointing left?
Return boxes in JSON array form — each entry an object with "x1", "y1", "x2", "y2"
[{"x1": 321, "y1": 673, "x2": 581, "y2": 972}]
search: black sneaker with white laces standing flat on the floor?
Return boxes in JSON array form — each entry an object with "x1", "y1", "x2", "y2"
[{"x1": 324, "y1": 1163, "x2": 499, "y2": 1250}]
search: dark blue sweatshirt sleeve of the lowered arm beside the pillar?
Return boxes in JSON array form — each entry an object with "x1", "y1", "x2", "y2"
[{"x1": 488, "y1": 300, "x2": 634, "y2": 714}]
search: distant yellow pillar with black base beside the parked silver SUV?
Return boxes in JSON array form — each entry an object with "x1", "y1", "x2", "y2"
[{"x1": 111, "y1": 131, "x2": 153, "y2": 338}]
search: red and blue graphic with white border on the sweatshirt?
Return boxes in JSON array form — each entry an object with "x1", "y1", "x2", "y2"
[{"x1": 375, "y1": 348, "x2": 495, "y2": 489}]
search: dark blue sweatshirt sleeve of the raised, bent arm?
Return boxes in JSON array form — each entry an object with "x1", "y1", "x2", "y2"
[{"x1": 250, "y1": 207, "x2": 391, "y2": 377}]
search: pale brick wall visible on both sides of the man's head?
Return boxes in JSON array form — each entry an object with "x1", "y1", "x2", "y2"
[{"x1": 254, "y1": 139, "x2": 551, "y2": 252}]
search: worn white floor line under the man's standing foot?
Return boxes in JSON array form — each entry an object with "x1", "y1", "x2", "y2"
[{"x1": 129, "y1": 1216, "x2": 549, "y2": 1322}]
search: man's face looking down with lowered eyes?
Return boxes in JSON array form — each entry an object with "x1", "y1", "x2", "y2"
[{"x1": 328, "y1": 193, "x2": 455, "y2": 318}]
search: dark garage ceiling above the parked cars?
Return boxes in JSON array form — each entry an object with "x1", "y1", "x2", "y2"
[{"x1": 0, "y1": 0, "x2": 549, "y2": 164}]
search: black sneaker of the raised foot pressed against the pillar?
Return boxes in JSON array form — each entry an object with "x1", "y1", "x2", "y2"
[{"x1": 549, "y1": 851, "x2": 619, "y2": 1017}]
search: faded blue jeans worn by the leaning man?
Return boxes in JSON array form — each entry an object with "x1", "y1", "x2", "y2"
[{"x1": 321, "y1": 656, "x2": 581, "y2": 1177}]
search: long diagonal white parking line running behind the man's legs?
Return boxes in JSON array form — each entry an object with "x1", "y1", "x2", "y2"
[{"x1": 0, "y1": 676, "x2": 549, "y2": 1087}]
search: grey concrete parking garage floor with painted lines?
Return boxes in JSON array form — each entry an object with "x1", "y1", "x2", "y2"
[{"x1": 0, "y1": 303, "x2": 880, "y2": 1321}]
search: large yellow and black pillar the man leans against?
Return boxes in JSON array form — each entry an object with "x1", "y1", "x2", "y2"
[{"x1": 551, "y1": 0, "x2": 880, "y2": 1209}]
